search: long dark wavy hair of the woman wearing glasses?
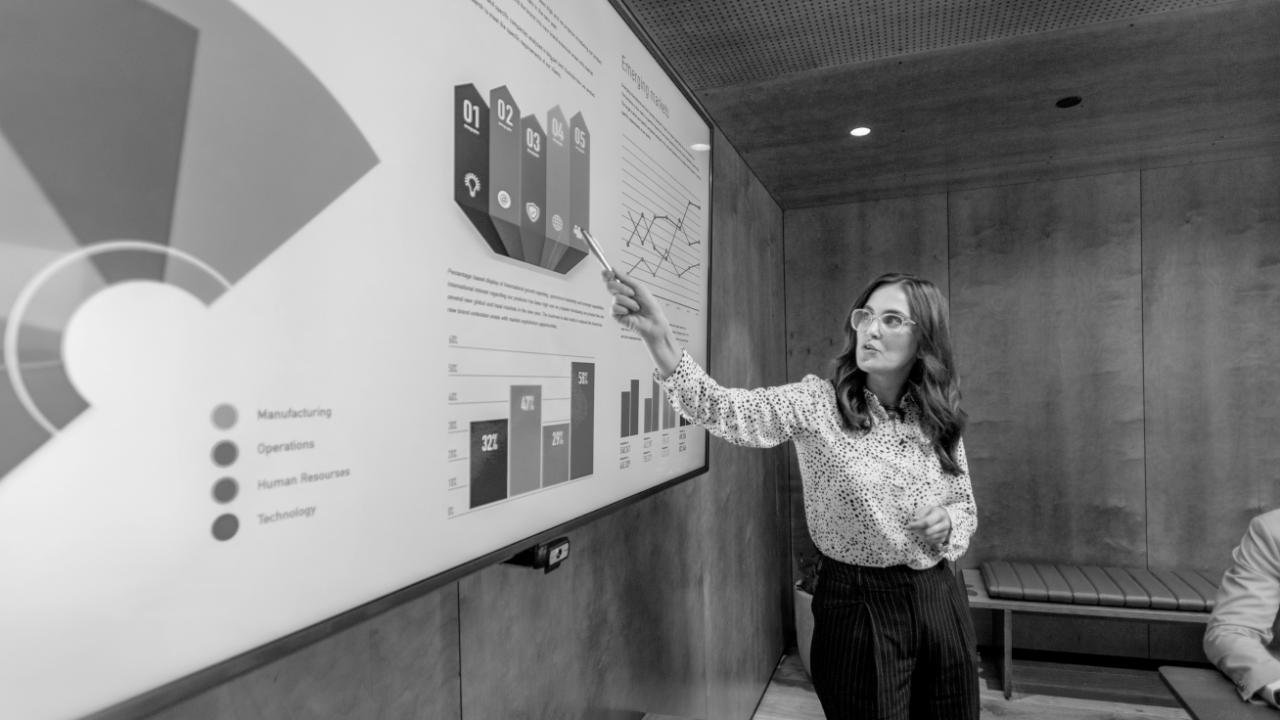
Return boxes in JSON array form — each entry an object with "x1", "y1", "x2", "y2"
[{"x1": 831, "y1": 273, "x2": 969, "y2": 475}]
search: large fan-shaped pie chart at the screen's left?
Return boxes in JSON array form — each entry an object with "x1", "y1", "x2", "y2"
[{"x1": 0, "y1": 0, "x2": 378, "y2": 480}]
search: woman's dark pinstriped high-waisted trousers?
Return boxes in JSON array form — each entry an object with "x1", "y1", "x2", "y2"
[{"x1": 809, "y1": 557, "x2": 979, "y2": 720}]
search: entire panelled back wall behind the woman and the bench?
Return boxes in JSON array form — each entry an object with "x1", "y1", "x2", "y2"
[{"x1": 786, "y1": 156, "x2": 1280, "y2": 660}]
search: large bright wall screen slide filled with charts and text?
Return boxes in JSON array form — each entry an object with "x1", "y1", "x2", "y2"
[{"x1": 0, "y1": 0, "x2": 710, "y2": 720}]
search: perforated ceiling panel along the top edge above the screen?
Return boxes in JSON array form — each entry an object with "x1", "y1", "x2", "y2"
[{"x1": 623, "y1": 0, "x2": 1231, "y2": 90}]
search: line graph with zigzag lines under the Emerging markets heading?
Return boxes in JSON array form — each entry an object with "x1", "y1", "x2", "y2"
[{"x1": 620, "y1": 135, "x2": 705, "y2": 307}]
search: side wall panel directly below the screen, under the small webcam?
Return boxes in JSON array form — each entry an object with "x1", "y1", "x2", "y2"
[{"x1": 460, "y1": 480, "x2": 707, "y2": 720}]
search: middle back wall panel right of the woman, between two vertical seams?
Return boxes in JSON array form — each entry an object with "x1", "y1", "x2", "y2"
[{"x1": 950, "y1": 173, "x2": 1147, "y2": 566}]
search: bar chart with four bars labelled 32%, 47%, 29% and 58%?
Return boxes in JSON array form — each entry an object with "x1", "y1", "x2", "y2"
[{"x1": 448, "y1": 337, "x2": 595, "y2": 516}]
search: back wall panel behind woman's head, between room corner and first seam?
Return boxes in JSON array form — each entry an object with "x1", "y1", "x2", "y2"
[{"x1": 785, "y1": 195, "x2": 948, "y2": 579}]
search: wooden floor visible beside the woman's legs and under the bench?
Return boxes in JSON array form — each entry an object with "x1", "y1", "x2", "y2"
[{"x1": 755, "y1": 653, "x2": 1189, "y2": 720}]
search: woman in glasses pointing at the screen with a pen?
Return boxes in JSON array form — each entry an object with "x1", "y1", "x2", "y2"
[{"x1": 604, "y1": 266, "x2": 978, "y2": 720}]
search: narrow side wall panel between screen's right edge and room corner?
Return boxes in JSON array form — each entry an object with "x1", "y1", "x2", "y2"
[{"x1": 696, "y1": 131, "x2": 790, "y2": 720}]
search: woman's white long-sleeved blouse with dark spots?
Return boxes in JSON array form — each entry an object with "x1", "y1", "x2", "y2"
[{"x1": 654, "y1": 352, "x2": 978, "y2": 570}]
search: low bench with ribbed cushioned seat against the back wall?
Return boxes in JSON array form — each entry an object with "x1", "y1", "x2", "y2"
[{"x1": 963, "y1": 562, "x2": 1219, "y2": 698}]
